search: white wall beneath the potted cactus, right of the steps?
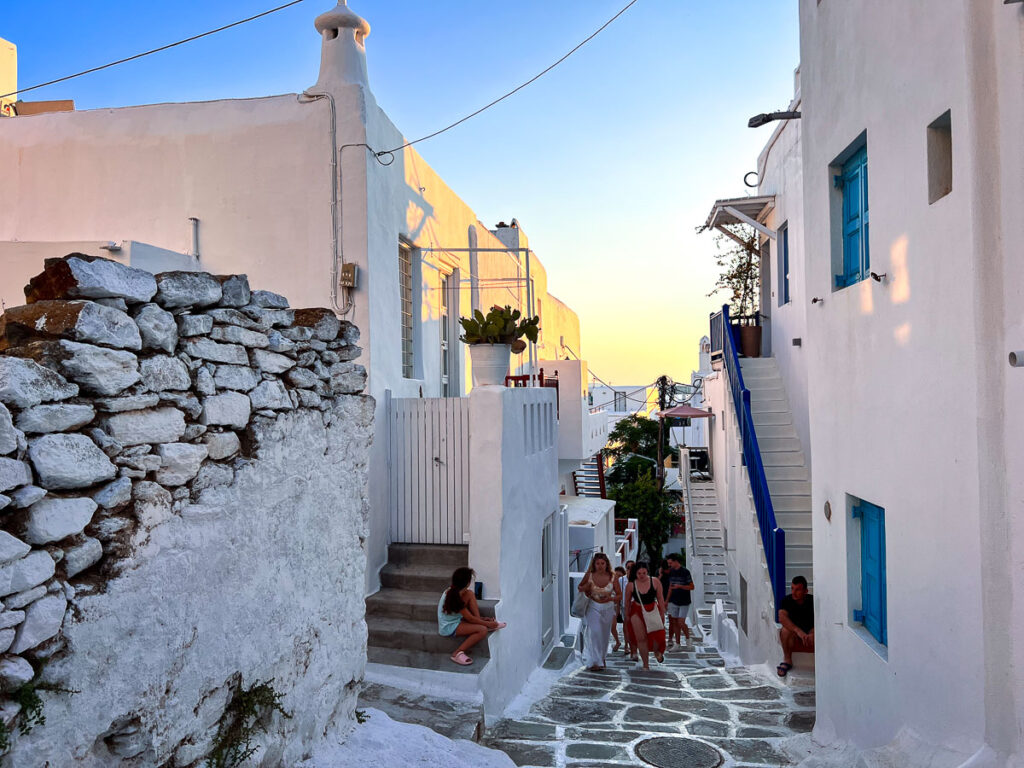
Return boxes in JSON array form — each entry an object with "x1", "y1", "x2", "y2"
[{"x1": 469, "y1": 386, "x2": 567, "y2": 719}]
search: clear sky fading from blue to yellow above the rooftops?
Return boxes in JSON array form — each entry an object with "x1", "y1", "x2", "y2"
[{"x1": 0, "y1": 0, "x2": 799, "y2": 384}]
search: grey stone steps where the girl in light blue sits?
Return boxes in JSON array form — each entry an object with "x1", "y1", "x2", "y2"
[{"x1": 367, "y1": 544, "x2": 495, "y2": 675}]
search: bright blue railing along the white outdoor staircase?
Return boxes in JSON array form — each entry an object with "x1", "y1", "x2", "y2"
[{"x1": 711, "y1": 305, "x2": 787, "y2": 617}]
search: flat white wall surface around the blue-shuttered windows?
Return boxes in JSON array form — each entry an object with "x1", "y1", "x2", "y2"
[{"x1": 801, "y1": 0, "x2": 1024, "y2": 765}]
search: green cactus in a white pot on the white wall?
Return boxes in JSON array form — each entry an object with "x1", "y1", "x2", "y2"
[{"x1": 459, "y1": 304, "x2": 541, "y2": 387}]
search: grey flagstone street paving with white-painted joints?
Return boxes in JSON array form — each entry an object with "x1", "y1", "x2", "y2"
[{"x1": 482, "y1": 641, "x2": 814, "y2": 768}]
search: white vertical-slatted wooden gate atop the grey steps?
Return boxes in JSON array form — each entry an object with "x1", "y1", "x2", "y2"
[{"x1": 388, "y1": 397, "x2": 469, "y2": 544}]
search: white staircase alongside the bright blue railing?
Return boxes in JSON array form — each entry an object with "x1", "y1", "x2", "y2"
[{"x1": 739, "y1": 357, "x2": 814, "y2": 589}]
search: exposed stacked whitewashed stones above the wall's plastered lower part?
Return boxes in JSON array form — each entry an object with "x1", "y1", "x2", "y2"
[{"x1": 0, "y1": 254, "x2": 366, "y2": 743}]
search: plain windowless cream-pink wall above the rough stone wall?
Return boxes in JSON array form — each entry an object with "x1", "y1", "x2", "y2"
[{"x1": 0, "y1": 95, "x2": 332, "y2": 306}]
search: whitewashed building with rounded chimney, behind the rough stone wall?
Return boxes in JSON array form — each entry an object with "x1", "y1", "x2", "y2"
[{"x1": 0, "y1": 1, "x2": 606, "y2": 713}]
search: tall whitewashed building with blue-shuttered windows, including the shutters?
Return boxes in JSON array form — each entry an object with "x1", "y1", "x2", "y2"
[{"x1": 696, "y1": 0, "x2": 1024, "y2": 766}]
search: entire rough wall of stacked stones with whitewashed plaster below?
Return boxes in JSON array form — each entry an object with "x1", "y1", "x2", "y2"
[{"x1": 0, "y1": 254, "x2": 373, "y2": 768}]
